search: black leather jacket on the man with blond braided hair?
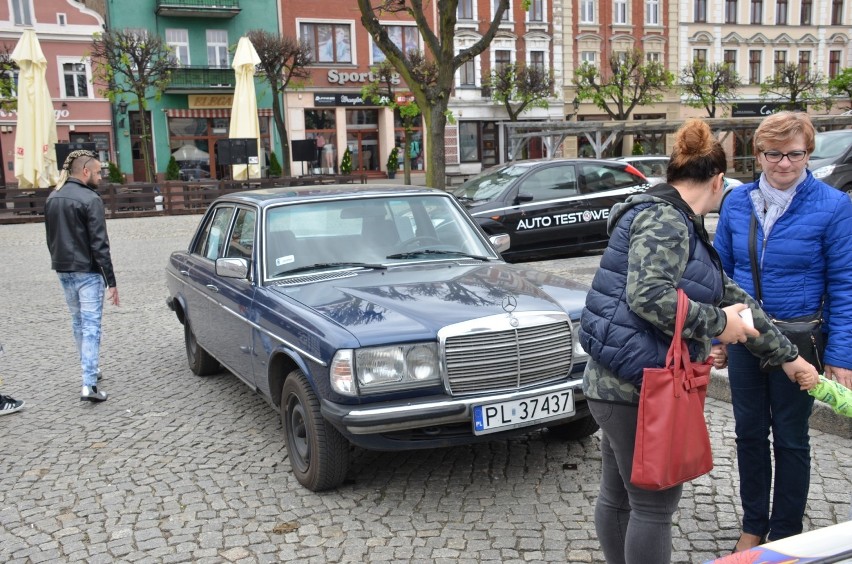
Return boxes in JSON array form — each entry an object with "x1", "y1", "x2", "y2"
[{"x1": 44, "y1": 178, "x2": 115, "y2": 288}]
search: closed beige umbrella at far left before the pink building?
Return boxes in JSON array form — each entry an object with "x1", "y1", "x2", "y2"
[{"x1": 12, "y1": 28, "x2": 59, "y2": 188}]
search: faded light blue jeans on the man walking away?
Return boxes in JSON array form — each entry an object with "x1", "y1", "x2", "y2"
[{"x1": 57, "y1": 272, "x2": 104, "y2": 386}]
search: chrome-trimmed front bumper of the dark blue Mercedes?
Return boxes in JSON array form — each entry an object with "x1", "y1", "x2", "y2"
[{"x1": 321, "y1": 378, "x2": 585, "y2": 443}]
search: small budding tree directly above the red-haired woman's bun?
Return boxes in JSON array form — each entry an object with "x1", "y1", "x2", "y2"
[{"x1": 680, "y1": 61, "x2": 740, "y2": 118}]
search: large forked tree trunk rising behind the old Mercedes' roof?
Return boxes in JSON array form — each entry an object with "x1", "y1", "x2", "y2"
[{"x1": 358, "y1": 0, "x2": 509, "y2": 188}]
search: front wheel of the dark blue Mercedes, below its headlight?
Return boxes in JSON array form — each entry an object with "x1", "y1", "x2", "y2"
[{"x1": 281, "y1": 370, "x2": 349, "y2": 492}]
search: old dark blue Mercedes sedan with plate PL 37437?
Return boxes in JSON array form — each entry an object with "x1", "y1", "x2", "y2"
[{"x1": 166, "y1": 185, "x2": 597, "y2": 491}]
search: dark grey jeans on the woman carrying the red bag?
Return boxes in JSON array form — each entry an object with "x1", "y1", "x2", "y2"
[{"x1": 589, "y1": 401, "x2": 683, "y2": 564}]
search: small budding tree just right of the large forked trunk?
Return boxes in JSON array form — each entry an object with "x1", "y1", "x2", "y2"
[{"x1": 490, "y1": 64, "x2": 554, "y2": 121}]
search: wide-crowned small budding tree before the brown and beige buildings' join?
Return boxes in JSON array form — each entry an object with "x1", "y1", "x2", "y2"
[{"x1": 574, "y1": 49, "x2": 675, "y2": 153}]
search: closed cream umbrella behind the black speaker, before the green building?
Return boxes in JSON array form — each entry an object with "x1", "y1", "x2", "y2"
[{"x1": 228, "y1": 37, "x2": 262, "y2": 180}]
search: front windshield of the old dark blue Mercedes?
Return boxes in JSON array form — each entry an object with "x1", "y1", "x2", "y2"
[{"x1": 263, "y1": 195, "x2": 496, "y2": 279}]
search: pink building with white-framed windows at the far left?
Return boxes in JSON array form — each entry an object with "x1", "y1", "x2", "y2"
[{"x1": 0, "y1": 0, "x2": 114, "y2": 183}]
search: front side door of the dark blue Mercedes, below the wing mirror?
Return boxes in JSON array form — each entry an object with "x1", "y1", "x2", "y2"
[{"x1": 207, "y1": 206, "x2": 257, "y2": 387}]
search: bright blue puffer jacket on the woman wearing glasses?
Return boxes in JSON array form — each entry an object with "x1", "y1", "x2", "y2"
[{"x1": 713, "y1": 171, "x2": 852, "y2": 368}]
